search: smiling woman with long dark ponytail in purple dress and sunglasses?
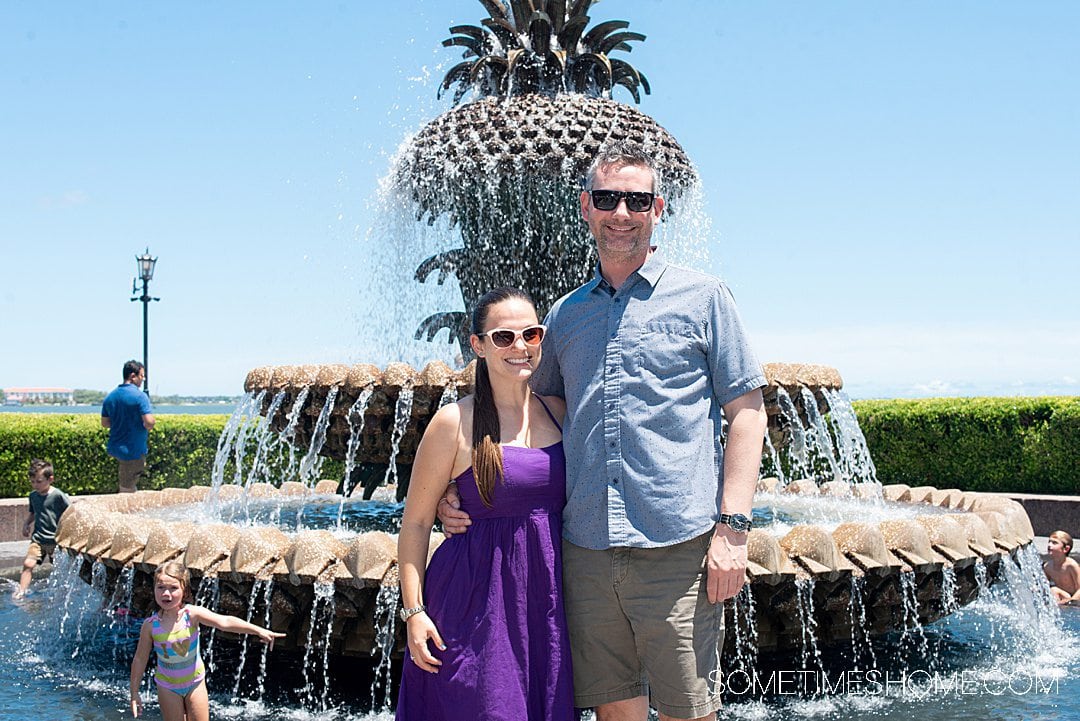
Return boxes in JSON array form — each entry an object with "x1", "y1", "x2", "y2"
[{"x1": 397, "y1": 288, "x2": 576, "y2": 721}]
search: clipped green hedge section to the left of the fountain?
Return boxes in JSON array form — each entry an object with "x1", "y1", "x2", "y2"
[{"x1": 0, "y1": 413, "x2": 228, "y2": 498}]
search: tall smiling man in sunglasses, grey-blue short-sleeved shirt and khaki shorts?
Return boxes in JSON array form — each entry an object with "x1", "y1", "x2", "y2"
[{"x1": 440, "y1": 144, "x2": 766, "y2": 721}]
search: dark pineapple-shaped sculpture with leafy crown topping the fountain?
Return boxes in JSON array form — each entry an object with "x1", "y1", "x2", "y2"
[{"x1": 395, "y1": 0, "x2": 697, "y2": 351}]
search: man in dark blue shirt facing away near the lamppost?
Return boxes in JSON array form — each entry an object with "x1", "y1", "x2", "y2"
[{"x1": 102, "y1": 361, "x2": 154, "y2": 493}]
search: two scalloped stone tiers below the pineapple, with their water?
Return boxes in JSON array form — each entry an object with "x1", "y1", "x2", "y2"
[{"x1": 57, "y1": 364, "x2": 1034, "y2": 654}]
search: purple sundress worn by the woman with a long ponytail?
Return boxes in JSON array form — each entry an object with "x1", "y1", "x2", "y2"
[{"x1": 396, "y1": 433, "x2": 577, "y2": 721}]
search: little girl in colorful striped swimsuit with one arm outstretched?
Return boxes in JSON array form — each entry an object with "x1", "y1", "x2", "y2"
[{"x1": 131, "y1": 561, "x2": 285, "y2": 721}]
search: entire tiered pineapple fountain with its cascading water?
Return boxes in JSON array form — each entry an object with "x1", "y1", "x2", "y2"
[{"x1": 46, "y1": 0, "x2": 1038, "y2": 706}]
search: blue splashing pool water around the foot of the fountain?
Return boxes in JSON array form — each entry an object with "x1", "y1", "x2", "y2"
[{"x1": 0, "y1": 552, "x2": 1080, "y2": 721}]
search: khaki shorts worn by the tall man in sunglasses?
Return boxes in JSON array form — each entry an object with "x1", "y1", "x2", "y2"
[{"x1": 563, "y1": 530, "x2": 724, "y2": 719}]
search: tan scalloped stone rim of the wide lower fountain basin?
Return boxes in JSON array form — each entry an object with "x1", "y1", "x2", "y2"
[{"x1": 57, "y1": 478, "x2": 1035, "y2": 587}]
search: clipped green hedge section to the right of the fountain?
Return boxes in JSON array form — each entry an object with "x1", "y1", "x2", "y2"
[{"x1": 854, "y1": 396, "x2": 1080, "y2": 493}]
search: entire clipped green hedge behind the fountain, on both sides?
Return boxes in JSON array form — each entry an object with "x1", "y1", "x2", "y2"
[{"x1": 0, "y1": 397, "x2": 1080, "y2": 498}]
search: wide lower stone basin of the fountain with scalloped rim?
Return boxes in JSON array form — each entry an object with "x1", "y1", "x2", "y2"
[{"x1": 57, "y1": 479, "x2": 1034, "y2": 655}]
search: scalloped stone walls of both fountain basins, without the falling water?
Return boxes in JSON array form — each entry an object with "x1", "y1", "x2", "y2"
[{"x1": 50, "y1": 364, "x2": 1034, "y2": 655}]
